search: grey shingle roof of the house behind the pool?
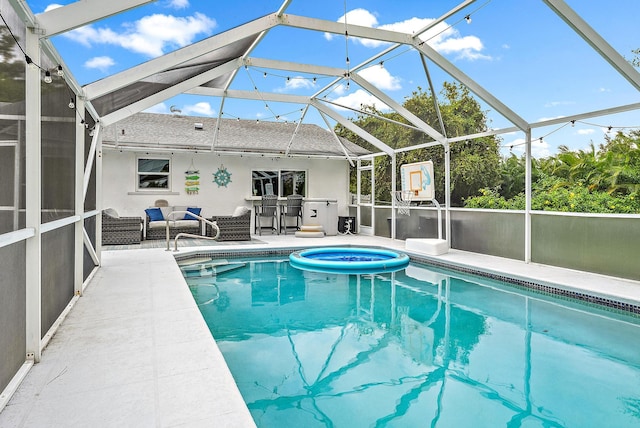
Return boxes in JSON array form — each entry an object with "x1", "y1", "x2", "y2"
[{"x1": 102, "y1": 113, "x2": 370, "y2": 156}]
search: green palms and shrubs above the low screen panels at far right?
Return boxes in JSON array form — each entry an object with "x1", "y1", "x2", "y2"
[{"x1": 465, "y1": 131, "x2": 640, "y2": 213}]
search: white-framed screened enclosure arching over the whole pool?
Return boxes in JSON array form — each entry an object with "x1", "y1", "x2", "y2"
[{"x1": 0, "y1": 0, "x2": 640, "y2": 409}]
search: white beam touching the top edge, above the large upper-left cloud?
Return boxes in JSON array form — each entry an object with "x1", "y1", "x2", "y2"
[{"x1": 36, "y1": 0, "x2": 155, "y2": 37}]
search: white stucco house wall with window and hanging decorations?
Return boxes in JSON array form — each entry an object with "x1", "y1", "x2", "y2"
[{"x1": 102, "y1": 150, "x2": 349, "y2": 221}]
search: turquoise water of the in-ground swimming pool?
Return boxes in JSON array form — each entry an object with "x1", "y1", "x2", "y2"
[{"x1": 185, "y1": 257, "x2": 640, "y2": 428}]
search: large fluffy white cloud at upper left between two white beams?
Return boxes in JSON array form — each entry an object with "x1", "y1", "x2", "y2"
[{"x1": 65, "y1": 13, "x2": 216, "y2": 57}]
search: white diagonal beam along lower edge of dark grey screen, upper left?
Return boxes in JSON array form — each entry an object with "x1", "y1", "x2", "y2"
[{"x1": 100, "y1": 58, "x2": 242, "y2": 126}]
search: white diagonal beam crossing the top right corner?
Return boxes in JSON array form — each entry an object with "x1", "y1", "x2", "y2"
[{"x1": 543, "y1": 0, "x2": 640, "y2": 91}]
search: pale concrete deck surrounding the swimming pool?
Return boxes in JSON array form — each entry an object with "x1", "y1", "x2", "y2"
[{"x1": 0, "y1": 235, "x2": 640, "y2": 427}]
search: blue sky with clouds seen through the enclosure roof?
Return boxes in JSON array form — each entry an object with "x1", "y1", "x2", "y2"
[{"x1": 27, "y1": 0, "x2": 640, "y2": 156}]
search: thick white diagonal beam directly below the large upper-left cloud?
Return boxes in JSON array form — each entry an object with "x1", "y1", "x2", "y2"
[{"x1": 84, "y1": 15, "x2": 277, "y2": 101}]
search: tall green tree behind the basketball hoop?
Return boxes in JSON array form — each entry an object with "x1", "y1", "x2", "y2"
[{"x1": 336, "y1": 82, "x2": 500, "y2": 206}]
